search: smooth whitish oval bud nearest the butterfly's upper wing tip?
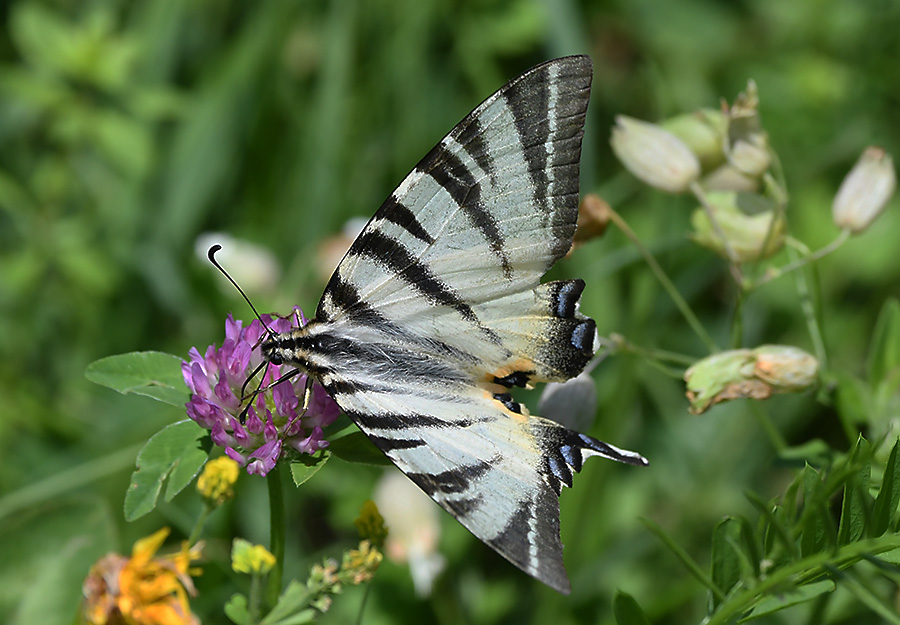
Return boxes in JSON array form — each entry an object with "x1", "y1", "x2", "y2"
[{"x1": 610, "y1": 115, "x2": 700, "y2": 193}]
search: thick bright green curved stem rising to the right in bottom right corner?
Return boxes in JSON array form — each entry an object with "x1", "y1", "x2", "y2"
[{"x1": 704, "y1": 535, "x2": 900, "y2": 625}]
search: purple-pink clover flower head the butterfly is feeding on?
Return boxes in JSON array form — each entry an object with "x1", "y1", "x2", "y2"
[{"x1": 181, "y1": 309, "x2": 340, "y2": 475}]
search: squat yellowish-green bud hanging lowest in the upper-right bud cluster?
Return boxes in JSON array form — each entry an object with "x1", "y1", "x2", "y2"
[{"x1": 691, "y1": 191, "x2": 785, "y2": 262}]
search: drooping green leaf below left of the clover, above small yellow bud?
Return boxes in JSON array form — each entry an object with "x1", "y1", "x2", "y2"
[{"x1": 125, "y1": 419, "x2": 208, "y2": 521}]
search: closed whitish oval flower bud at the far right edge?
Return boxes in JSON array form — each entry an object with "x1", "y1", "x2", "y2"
[{"x1": 832, "y1": 147, "x2": 897, "y2": 234}]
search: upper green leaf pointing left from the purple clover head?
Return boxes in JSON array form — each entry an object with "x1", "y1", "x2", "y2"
[{"x1": 84, "y1": 352, "x2": 188, "y2": 407}]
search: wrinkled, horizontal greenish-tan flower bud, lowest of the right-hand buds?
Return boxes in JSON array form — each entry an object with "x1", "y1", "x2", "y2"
[{"x1": 684, "y1": 345, "x2": 819, "y2": 414}]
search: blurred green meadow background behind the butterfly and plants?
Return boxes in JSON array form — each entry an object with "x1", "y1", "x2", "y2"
[{"x1": 0, "y1": 0, "x2": 900, "y2": 625}]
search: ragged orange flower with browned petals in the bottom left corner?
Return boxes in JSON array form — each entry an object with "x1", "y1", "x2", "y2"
[{"x1": 83, "y1": 528, "x2": 200, "y2": 625}]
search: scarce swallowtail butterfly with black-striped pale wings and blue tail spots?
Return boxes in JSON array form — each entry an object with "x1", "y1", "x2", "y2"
[{"x1": 262, "y1": 56, "x2": 647, "y2": 593}]
